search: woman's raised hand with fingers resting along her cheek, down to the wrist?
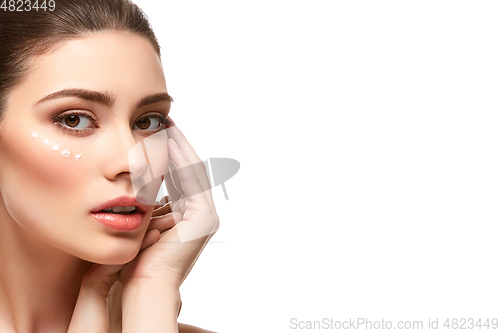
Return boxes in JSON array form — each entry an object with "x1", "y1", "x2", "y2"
[{"x1": 119, "y1": 117, "x2": 219, "y2": 288}]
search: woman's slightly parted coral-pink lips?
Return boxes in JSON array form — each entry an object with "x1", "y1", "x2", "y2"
[{"x1": 90, "y1": 196, "x2": 149, "y2": 231}]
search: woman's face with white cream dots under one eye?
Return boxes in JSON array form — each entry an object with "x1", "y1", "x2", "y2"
[{"x1": 0, "y1": 32, "x2": 170, "y2": 264}]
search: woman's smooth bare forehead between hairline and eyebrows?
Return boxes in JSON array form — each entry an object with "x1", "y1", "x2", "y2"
[{"x1": 13, "y1": 31, "x2": 166, "y2": 104}]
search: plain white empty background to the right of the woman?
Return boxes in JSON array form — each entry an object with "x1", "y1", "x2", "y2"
[{"x1": 131, "y1": 0, "x2": 500, "y2": 333}]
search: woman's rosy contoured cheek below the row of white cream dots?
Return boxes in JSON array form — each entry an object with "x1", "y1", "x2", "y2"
[{"x1": 0, "y1": 133, "x2": 89, "y2": 223}]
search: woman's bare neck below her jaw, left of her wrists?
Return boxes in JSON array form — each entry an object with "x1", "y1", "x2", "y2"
[{"x1": 0, "y1": 211, "x2": 92, "y2": 333}]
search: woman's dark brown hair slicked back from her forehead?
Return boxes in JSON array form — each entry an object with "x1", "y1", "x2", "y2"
[{"x1": 0, "y1": 0, "x2": 160, "y2": 122}]
